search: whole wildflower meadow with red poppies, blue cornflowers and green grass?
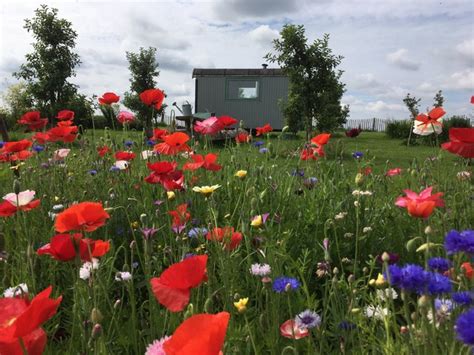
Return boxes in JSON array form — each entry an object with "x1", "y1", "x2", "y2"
[{"x1": 0, "y1": 93, "x2": 474, "y2": 355}]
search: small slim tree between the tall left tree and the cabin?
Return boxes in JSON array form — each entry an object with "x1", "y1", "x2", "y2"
[{"x1": 124, "y1": 47, "x2": 165, "y2": 134}]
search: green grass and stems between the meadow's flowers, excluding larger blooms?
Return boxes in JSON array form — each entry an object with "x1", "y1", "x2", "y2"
[{"x1": 0, "y1": 131, "x2": 474, "y2": 354}]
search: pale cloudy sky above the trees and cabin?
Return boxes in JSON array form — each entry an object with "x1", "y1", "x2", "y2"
[{"x1": 0, "y1": 0, "x2": 474, "y2": 119}]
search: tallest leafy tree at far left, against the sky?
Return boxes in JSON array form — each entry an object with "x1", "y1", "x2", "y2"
[{"x1": 13, "y1": 5, "x2": 80, "y2": 117}]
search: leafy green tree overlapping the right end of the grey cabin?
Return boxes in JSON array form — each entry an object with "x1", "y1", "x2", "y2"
[{"x1": 265, "y1": 25, "x2": 349, "y2": 139}]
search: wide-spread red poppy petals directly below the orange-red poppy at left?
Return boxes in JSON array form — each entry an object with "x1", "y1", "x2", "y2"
[{"x1": 37, "y1": 233, "x2": 110, "y2": 261}]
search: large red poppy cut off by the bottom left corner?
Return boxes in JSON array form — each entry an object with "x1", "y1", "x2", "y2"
[{"x1": 0, "y1": 286, "x2": 62, "y2": 355}]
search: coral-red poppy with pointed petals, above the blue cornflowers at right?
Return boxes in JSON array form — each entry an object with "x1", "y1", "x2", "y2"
[{"x1": 395, "y1": 187, "x2": 444, "y2": 218}]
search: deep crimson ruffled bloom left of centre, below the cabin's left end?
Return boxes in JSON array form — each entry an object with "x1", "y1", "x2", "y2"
[{"x1": 145, "y1": 161, "x2": 184, "y2": 191}]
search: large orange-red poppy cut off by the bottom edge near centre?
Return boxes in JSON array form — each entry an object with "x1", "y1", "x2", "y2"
[{"x1": 163, "y1": 312, "x2": 230, "y2": 355}]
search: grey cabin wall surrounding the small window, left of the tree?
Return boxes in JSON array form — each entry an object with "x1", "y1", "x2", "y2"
[{"x1": 195, "y1": 76, "x2": 288, "y2": 129}]
